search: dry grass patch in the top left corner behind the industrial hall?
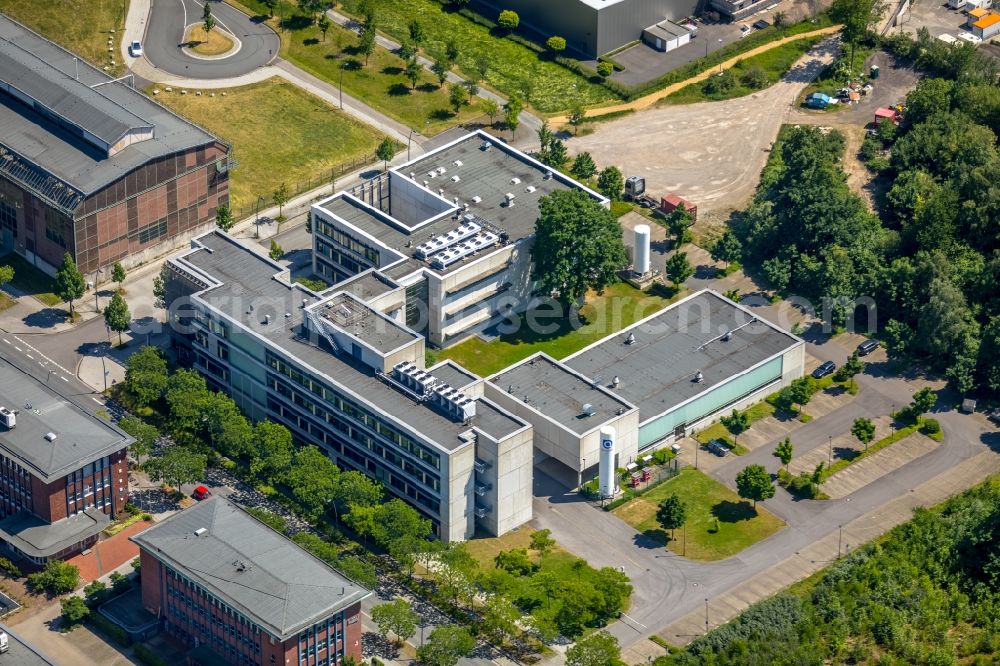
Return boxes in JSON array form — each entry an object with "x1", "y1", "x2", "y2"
[{"x1": 0, "y1": 0, "x2": 128, "y2": 73}]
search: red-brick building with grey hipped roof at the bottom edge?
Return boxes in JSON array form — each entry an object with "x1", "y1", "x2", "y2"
[{"x1": 131, "y1": 497, "x2": 371, "y2": 666}]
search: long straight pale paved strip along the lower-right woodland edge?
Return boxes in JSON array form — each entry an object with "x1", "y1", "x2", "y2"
[{"x1": 644, "y1": 451, "x2": 1000, "y2": 652}]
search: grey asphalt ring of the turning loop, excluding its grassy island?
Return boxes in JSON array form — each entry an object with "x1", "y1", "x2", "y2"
[{"x1": 143, "y1": 0, "x2": 281, "y2": 79}]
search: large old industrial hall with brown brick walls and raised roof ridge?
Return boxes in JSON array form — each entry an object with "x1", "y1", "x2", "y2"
[{"x1": 0, "y1": 15, "x2": 230, "y2": 283}]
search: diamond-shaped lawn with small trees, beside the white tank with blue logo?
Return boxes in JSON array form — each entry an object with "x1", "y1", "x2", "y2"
[{"x1": 613, "y1": 468, "x2": 785, "y2": 560}]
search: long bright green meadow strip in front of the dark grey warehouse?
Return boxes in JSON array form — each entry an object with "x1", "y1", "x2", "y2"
[{"x1": 330, "y1": 0, "x2": 613, "y2": 113}]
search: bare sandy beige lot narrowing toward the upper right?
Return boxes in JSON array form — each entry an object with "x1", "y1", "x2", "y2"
[{"x1": 568, "y1": 39, "x2": 837, "y2": 217}]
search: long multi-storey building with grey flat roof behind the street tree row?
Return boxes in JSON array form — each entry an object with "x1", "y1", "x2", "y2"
[{"x1": 167, "y1": 231, "x2": 532, "y2": 541}]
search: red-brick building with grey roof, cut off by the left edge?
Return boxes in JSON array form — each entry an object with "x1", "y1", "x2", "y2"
[{"x1": 0, "y1": 360, "x2": 132, "y2": 566}]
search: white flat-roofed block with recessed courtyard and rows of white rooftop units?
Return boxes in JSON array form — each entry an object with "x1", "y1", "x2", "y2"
[{"x1": 311, "y1": 132, "x2": 609, "y2": 347}]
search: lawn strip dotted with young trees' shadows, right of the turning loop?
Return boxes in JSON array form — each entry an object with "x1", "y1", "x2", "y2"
[{"x1": 282, "y1": 24, "x2": 483, "y2": 135}]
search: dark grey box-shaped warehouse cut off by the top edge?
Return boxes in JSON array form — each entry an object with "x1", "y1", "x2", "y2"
[{"x1": 479, "y1": 0, "x2": 698, "y2": 58}]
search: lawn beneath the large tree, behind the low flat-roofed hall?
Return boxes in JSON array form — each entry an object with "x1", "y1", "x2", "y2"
[{"x1": 436, "y1": 282, "x2": 679, "y2": 377}]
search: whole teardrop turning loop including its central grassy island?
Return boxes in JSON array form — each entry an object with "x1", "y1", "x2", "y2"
[{"x1": 142, "y1": 0, "x2": 281, "y2": 80}]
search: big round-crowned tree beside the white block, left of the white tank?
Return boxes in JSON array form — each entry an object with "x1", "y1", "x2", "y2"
[{"x1": 531, "y1": 190, "x2": 626, "y2": 308}]
